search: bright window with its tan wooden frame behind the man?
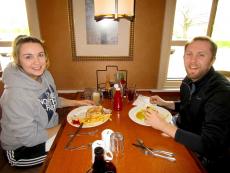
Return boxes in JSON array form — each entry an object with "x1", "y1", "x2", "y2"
[{"x1": 158, "y1": 0, "x2": 230, "y2": 88}]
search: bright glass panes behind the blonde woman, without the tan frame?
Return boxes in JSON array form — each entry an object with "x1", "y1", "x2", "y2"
[{"x1": 0, "y1": 0, "x2": 30, "y2": 70}]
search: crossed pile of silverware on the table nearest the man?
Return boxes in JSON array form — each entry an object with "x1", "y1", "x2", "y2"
[{"x1": 133, "y1": 139, "x2": 176, "y2": 162}]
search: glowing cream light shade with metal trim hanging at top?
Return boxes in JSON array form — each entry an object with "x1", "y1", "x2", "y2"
[{"x1": 94, "y1": 0, "x2": 135, "y2": 21}]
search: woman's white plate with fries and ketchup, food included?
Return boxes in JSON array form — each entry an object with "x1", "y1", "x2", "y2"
[{"x1": 67, "y1": 106, "x2": 112, "y2": 128}]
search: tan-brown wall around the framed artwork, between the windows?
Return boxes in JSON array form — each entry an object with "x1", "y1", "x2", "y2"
[{"x1": 37, "y1": 0, "x2": 165, "y2": 90}]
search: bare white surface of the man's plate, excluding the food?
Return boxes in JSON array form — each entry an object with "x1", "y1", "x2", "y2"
[{"x1": 129, "y1": 106, "x2": 172, "y2": 126}]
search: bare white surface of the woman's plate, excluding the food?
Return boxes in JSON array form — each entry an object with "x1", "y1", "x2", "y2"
[{"x1": 67, "y1": 106, "x2": 109, "y2": 128}]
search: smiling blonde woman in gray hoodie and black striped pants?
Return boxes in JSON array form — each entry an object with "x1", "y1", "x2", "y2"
[{"x1": 0, "y1": 35, "x2": 94, "y2": 167}]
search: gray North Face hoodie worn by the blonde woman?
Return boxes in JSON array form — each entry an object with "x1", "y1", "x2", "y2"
[{"x1": 0, "y1": 63, "x2": 59, "y2": 150}]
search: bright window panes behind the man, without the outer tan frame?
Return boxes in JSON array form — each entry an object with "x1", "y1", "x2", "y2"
[{"x1": 167, "y1": 0, "x2": 230, "y2": 80}]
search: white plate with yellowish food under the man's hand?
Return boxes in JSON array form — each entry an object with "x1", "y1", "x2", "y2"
[{"x1": 129, "y1": 105, "x2": 172, "y2": 126}]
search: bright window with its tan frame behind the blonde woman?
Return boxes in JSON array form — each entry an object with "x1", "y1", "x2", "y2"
[{"x1": 0, "y1": 0, "x2": 40, "y2": 71}]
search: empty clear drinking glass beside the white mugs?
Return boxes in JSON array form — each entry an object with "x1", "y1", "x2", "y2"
[{"x1": 110, "y1": 132, "x2": 124, "y2": 161}]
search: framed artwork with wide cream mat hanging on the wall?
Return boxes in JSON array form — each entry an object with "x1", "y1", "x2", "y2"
[{"x1": 68, "y1": 0, "x2": 134, "y2": 61}]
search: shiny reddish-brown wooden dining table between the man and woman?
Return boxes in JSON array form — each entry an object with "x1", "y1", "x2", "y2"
[{"x1": 41, "y1": 91, "x2": 206, "y2": 173}]
